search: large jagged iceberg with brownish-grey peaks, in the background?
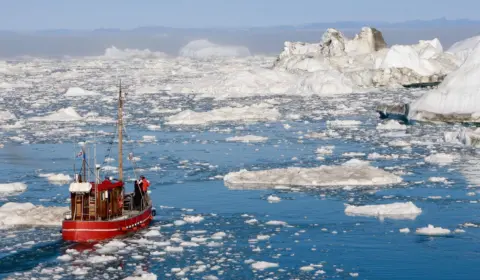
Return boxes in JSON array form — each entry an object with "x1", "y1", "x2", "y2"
[{"x1": 274, "y1": 27, "x2": 459, "y2": 88}]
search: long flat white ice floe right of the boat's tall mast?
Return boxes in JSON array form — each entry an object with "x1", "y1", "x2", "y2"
[{"x1": 166, "y1": 103, "x2": 281, "y2": 125}]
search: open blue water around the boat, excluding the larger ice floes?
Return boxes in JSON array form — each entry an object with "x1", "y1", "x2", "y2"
[{"x1": 0, "y1": 95, "x2": 480, "y2": 279}]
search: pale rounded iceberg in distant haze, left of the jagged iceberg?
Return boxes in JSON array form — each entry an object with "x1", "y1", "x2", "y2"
[{"x1": 179, "y1": 39, "x2": 250, "y2": 58}]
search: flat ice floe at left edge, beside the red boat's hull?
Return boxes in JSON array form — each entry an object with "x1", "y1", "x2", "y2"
[{"x1": 0, "y1": 202, "x2": 68, "y2": 228}]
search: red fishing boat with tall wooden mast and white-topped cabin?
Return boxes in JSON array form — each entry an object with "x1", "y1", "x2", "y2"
[{"x1": 62, "y1": 84, "x2": 155, "y2": 242}]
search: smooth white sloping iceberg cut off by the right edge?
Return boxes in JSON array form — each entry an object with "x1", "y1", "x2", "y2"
[{"x1": 409, "y1": 39, "x2": 480, "y2": 121}]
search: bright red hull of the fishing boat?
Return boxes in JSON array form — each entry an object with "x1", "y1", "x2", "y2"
[{"x1": 62, "y1": 206, "x2": 153, "y2": 242}]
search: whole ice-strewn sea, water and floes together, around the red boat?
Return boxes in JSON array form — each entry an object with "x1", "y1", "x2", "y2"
[{"x1": 0, "y1": 29, "x2": 480, "y2": 279}]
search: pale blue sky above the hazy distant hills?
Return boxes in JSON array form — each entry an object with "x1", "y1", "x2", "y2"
[{"x1": 0, "y1": 0, "x2": 480, "y2": 30}]
